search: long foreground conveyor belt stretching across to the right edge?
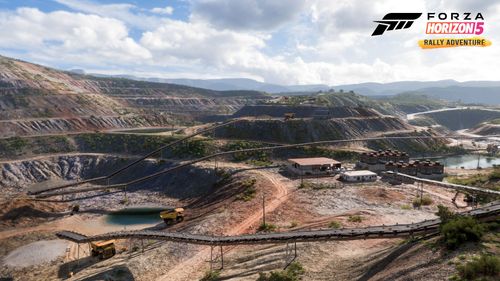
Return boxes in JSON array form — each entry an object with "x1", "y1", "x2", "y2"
[{"x1": 56, "y1": 201, "x2": 500, "y2": 246}]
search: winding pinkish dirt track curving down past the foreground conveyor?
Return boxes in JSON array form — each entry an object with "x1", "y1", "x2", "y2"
[{"x1": 157, "y1": 168, "x2": 288, "y2": 281}]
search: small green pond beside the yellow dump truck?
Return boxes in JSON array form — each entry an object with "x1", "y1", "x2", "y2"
[{"x1": 106, "y1": 208, "x2": 164, "y2": 225}]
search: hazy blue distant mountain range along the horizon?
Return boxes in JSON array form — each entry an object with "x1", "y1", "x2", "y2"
[{"x1": 74, "y1": 70, "x2": 500, "y2": 104}]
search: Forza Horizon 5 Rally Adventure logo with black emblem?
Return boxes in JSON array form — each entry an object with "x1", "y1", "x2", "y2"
[{"x1": 372, "y1": 12, "x2": 491, "y2": 49}]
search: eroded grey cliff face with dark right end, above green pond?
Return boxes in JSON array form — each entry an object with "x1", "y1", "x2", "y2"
[{"x1": 0, "y1": 154, "x2": 216, "y2": 198}]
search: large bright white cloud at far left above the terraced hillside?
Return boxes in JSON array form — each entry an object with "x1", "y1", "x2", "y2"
[{"x1": 0, "y1": 8, "x2": 151, "y2": 63}]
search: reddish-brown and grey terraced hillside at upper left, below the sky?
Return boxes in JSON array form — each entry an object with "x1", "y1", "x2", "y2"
[{"x1": 0, "y1": 56, "x2": 268, "y2": 137}]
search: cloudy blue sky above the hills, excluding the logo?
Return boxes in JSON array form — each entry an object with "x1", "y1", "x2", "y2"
[{"x1": 0, "y1": 0, "x2": 500, "y2": 85}]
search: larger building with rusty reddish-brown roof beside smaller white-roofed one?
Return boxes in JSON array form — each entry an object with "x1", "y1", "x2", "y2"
[{"x1": 287, "y1": 157, "x2": 341, "y2": 175}]
